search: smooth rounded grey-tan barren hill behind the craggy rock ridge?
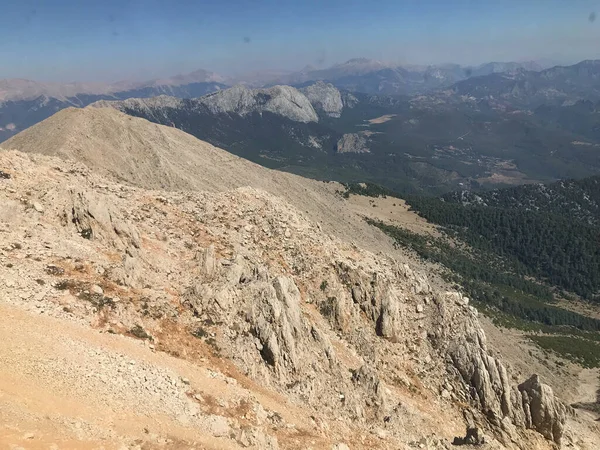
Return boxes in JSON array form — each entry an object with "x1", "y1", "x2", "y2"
[{"x1": 2, "y1": 107, "x2": 393, "y2": 251}]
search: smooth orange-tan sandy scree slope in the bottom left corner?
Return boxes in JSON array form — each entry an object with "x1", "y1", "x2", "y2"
[{"x1": 0, "y1": 302, "x2": 331, "y2": 449}]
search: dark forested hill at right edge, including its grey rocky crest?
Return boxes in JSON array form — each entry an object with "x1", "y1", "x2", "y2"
[{"x1": 407, "y1": 177, "x2": 600, "y2": 302}]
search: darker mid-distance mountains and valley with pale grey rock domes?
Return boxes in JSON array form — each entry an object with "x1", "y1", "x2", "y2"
[{"x1": 88, "y1": 75, "x2": 600, "y2": 194}]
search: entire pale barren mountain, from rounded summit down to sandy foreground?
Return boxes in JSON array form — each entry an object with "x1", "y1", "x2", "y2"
[{"x1": 0, "y1": 107, "x2": 600, "y2": 450}]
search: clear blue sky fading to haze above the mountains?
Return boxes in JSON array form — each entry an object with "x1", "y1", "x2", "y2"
[{"x1": 0, "y1": 0, "x2": 600, "y2": 82}]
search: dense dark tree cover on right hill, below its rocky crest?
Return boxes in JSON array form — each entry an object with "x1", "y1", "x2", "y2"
[{"x1": 407, "y1": 197, "x2": 600, "y2": 301}]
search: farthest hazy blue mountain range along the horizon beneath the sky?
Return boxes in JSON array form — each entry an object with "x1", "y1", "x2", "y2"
[{"x1": 0, "y1": 58, "x2": 538, "y2": 142}]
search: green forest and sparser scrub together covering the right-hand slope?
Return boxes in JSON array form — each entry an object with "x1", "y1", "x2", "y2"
[{"x1": 342, "y1": 177, "x2": 600, "y2": 366}]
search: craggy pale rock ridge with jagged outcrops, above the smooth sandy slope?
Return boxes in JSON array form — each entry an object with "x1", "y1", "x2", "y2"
[{"x1": 0, "y1": 147, "x2": 584, "y2": 448}]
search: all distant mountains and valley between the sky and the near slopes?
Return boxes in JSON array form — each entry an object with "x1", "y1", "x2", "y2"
[{"x1": 0, "y1": 59, "x2": 600, "y2": 194}]
